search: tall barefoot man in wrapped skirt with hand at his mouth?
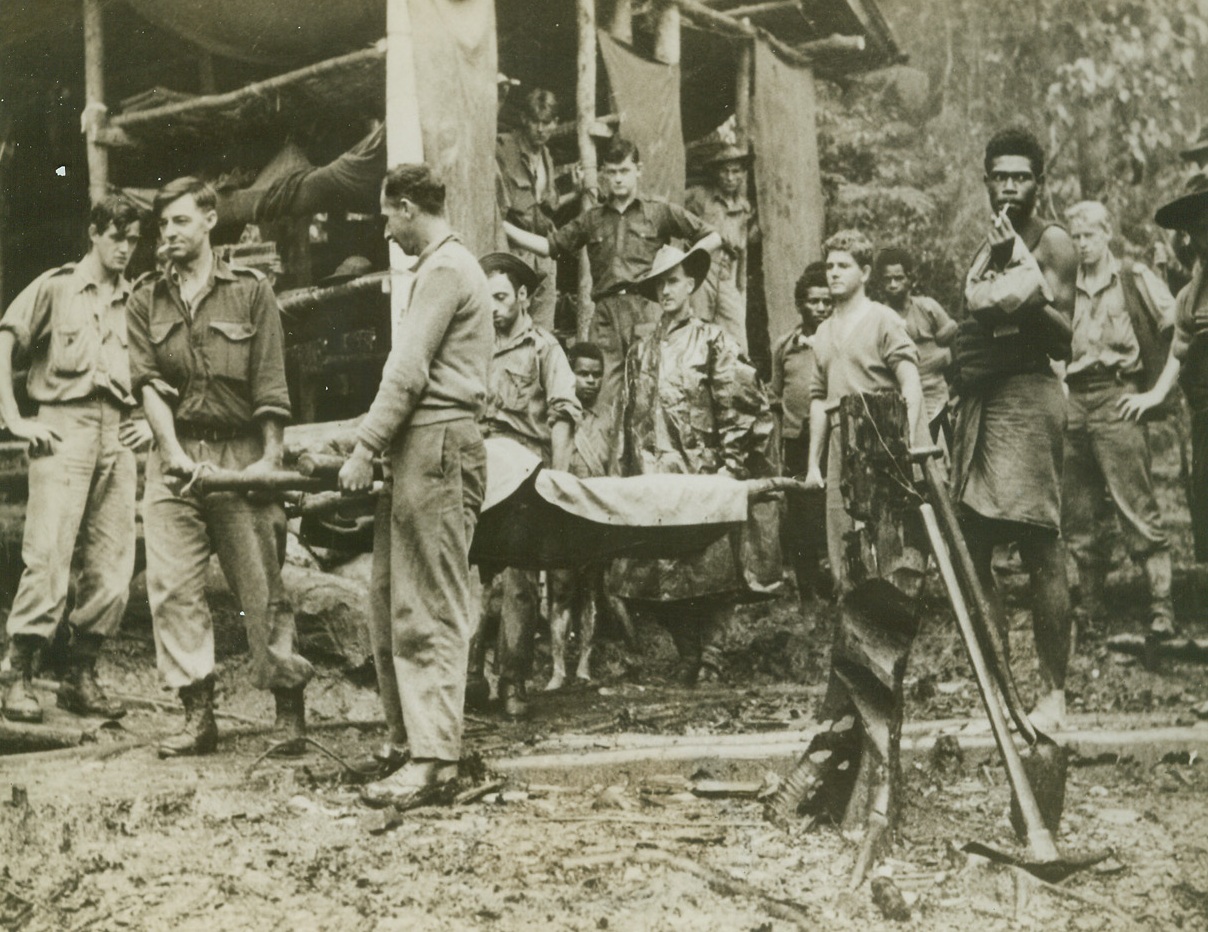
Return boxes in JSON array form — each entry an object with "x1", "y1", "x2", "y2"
[{"x1": 952, "y1": 128, "x2": 1078, "y2": 730}]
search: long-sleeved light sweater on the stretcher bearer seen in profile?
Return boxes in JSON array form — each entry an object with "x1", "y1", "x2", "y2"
[{"x1": 356, "y1": 233, "x2": 495, "y2": 453}]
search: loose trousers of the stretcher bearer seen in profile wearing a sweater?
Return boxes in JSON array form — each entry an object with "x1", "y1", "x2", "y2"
[{"x1": 371, "y1": 418, "x2": 487, "y2": 761}]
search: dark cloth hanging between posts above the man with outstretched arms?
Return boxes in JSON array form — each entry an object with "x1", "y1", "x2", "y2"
[{"x1": 599, "y1": 33, "x2": 685, "y2": 204}]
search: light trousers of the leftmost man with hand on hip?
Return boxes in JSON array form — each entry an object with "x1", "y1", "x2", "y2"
[{"x1": 8, "y1": 398, "x2": 138, "y2": 640}]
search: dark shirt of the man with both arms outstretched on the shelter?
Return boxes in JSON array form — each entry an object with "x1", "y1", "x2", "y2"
[{"x1": 550, "y1": 196, "x2": 713, "y2": 298}]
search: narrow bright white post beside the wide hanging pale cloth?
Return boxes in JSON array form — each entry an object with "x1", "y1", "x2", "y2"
[{"x1": 385, "y1": 0, "x2": 424, "y2": 322}]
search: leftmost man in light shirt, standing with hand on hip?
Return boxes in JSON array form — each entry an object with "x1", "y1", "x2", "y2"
[{"x1": 0, "y1": 197, "x2": 145, "y2": 722}]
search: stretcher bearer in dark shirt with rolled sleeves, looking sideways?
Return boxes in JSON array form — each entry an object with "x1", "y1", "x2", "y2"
[{"x1": 129, "y1": 177, "x2": 314, "y2": 757}]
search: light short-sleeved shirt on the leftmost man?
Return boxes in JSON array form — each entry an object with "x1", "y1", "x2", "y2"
[{"x1": 0, "y1": 263, "x2": 134, "y2": 404}]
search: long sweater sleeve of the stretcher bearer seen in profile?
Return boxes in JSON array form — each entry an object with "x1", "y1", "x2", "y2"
[{"x1": 356, "y1": 266, "x2": 461, "y2": 453}]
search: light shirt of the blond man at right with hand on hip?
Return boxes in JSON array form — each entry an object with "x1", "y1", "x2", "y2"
[{"x1": 1065, "y1": 254, "x2": 1174, "y2": 377}]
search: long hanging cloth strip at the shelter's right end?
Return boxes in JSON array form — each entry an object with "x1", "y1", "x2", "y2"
[{"x1": 751, "y1": 42, "x2": 825, "y2": 343}]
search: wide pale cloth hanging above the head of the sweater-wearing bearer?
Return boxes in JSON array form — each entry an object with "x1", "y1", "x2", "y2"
[{"x1": 411, "y1": 0, "x2": 498, "y2": 256}]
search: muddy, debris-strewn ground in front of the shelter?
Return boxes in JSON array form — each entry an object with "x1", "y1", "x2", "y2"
[{"x1": 0, "y1": 432, "x2": 1208, "y2": 932}]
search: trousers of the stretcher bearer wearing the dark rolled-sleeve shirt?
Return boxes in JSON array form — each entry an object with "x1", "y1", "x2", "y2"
[{"x1": 143, "y1": 437, "x2": 314, "y2": 689}]
